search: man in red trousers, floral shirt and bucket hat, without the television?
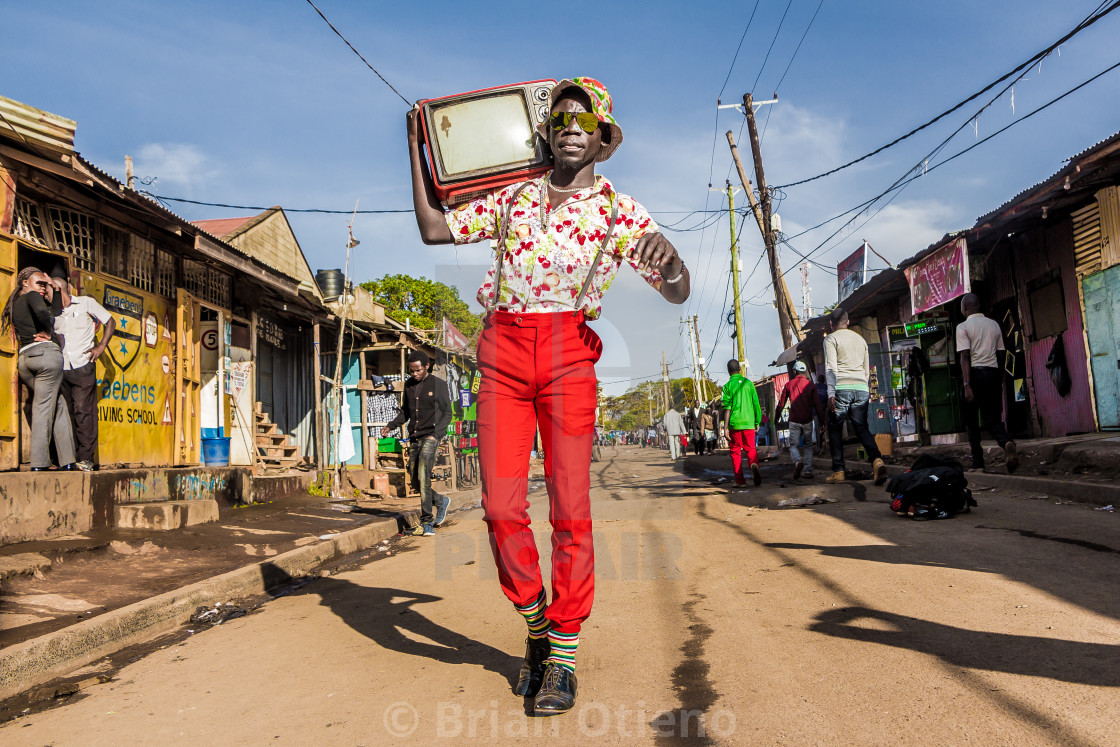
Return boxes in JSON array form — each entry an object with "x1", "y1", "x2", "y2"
[{"x1": 408, "y1": 77, "x2": 689, "y2": 715}]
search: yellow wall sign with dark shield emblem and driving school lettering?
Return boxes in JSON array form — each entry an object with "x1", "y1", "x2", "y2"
[{"x1": 81, "y1": 272, "x2": 175, "y2": 466}]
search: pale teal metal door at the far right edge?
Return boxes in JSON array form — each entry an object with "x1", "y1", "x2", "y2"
[{"x1": 1081, "y1": 265, "x2": 1120, "y2": 429}]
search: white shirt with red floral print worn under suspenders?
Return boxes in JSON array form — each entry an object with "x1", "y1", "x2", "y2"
[{"x1": 447, "y1": 175, "x2": 661, "y2": 319}]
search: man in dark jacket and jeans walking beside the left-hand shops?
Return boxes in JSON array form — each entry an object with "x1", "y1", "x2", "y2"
[{"x1": 381, "y1": 351, "x2": 452, "y2": 536}]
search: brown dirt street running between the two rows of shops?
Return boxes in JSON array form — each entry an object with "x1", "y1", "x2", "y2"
[{"x1": 0, "y1": 447, "x2": 1120, "y2": 745}]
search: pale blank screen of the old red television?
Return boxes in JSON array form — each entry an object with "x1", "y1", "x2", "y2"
[{"x1": 431, "y1": 91, "x2": 536, "y2": 179}]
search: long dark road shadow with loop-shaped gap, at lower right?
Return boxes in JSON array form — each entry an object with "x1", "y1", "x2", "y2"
[{"x1": 809, "y1": 607, "x2": 1120, "y2": 688}]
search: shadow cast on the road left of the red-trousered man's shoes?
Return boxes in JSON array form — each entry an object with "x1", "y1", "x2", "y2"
[{"x1": 265, "y1": 567, "x2": 521, "y2": 687}]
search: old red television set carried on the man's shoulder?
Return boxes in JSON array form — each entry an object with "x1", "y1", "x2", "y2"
[{"x1": 419, "y1": 81, "x2": 557, "y2": 207}]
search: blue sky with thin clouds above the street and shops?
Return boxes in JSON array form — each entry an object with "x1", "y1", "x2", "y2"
[{"x1": 8, "y1": 0, "x2": 1120, "y2": 393}]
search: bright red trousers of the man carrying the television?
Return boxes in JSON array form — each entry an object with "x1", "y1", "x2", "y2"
[{"x1": 478, "y1": 311, "x2": 603, "y2": 634}]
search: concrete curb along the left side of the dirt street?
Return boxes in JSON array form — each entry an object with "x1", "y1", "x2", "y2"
[{"x1": 0, "y1": 488, "x2": 480, "y2": 700}]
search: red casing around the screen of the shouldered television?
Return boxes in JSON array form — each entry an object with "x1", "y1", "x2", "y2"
[{"x1": 419, "y1": 80, "x2": 557, "y2": 207}]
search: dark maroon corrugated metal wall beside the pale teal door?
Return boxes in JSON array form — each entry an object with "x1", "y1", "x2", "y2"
[{"x1": 1016, "y1": 218, "x2": 1095, "y2": 436}]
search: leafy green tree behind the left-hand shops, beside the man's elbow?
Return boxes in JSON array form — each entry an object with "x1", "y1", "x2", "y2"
[{"x1": 362, "y1": 274, "x2": 482, "y2": 340}]
